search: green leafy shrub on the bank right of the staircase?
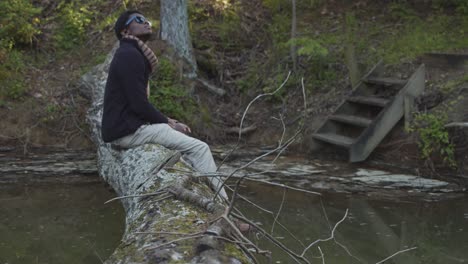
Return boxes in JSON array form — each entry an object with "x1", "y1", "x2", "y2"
[{"x1": 409, "y1": 112, "x2": 456, "y2": 167}]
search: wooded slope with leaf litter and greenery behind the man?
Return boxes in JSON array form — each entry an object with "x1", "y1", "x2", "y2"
[{"x1": 0, "y1": 0, "x2": 468, "y2": 177}]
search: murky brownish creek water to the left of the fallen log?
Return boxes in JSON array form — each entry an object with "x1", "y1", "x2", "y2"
[{"x1": 0, "y1": 184, "x2": 125, "y2": 264}]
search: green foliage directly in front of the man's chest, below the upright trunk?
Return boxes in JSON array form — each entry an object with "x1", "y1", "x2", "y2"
[{"x1": 150, "y1": 58, "x2": 196, "y2": 121}]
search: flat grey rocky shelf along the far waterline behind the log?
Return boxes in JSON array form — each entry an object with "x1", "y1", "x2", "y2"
[{"x1": 0, "y1": 147, "x2": 466, "y2": 202}]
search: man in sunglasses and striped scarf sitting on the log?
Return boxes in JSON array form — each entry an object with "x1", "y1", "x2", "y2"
[{"x1": 102, "y1": 11, "x2": 227, "y2": 199}]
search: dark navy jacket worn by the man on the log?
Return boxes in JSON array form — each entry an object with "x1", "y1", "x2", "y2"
[{"x1": 101, "y1": 39, "x2": 167, "y2": 142}]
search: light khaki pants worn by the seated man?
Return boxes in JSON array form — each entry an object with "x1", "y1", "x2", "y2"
[{"x1": 112, "y1": 124, "x2": 228, "y2": 199}]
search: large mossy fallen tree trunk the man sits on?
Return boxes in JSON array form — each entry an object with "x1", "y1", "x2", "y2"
[{"x1": 81, "y1": 42, "x2": 251, "y2": 264}]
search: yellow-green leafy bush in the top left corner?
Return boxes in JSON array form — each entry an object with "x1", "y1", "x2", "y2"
[{"x1": 0, "y1": 0, "x2": 42, "y2": 44}]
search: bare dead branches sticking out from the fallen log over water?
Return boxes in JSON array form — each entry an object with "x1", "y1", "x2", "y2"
[{"x1": 97, "y1": 69, "x2": 418, "y2": 263}]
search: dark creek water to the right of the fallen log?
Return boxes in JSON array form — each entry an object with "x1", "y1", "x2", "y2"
[{"x1": 242, "y1": 184, "x2": 468, "y2": 264}]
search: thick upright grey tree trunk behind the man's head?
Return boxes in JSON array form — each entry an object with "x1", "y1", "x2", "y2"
[{"x1": 160, "y1": 0, "x2": 197, "y2": 78}]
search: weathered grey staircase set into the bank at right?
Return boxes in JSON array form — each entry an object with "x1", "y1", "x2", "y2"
[{"x1": 312, "y1": 63, "x2": 425, "y2": 162}]
